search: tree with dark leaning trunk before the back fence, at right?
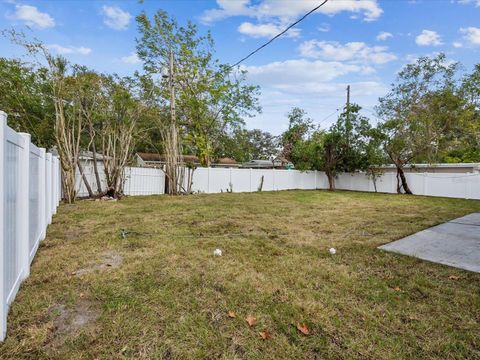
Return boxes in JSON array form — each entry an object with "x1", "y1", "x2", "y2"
[{"x1": 377, "y1": 54, "x2": 461, "y2": 194}]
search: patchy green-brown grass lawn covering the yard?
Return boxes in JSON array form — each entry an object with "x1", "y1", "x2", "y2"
[{"x1": 0, "y1": 191, "x2": 480, "y2": 359}]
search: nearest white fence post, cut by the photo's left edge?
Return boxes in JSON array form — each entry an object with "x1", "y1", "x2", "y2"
[{"x1": 0, "y1": 111, "x2": 7, "y2": 341}]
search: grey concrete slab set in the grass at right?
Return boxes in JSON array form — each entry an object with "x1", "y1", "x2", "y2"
[{"x1": 379, "y1": 213, "x2": 480, "y2": 272}]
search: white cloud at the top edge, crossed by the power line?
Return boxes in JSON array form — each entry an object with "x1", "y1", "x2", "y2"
[{"x1": 201, "y1": 0, "x2": 383, "y2": 23}]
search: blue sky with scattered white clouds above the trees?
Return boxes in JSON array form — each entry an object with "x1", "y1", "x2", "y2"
[{"x1": 0, "y1": 0, "x2": 480, "y2": 134}]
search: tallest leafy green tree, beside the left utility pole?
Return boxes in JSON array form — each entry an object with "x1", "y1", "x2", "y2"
[{"x1": 137, "y1": 11, "x2": 260, "y2": 176}]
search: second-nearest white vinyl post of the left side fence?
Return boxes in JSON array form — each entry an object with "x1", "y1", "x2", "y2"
[{"x1": 17, "y1": 133, "x2": 31, "y2": 279}]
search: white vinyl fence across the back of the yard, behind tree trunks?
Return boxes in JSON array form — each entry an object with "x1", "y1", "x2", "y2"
[{"x1": 77, "y1": 163, "x2": 480, "y2": 200}]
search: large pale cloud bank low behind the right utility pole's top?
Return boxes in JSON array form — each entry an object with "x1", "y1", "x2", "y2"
[{"x1": 243, "y1": 59, "x2": 388, "y2": 134}]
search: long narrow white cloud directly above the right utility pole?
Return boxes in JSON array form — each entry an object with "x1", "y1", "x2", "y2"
[{"x1": 299, "y1": 40, "x2": 397, "y2": 64}]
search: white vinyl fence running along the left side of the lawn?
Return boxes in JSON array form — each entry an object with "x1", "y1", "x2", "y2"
[{"x1": 0, "y1": 111, "x2": 61, "y2": 341}]
